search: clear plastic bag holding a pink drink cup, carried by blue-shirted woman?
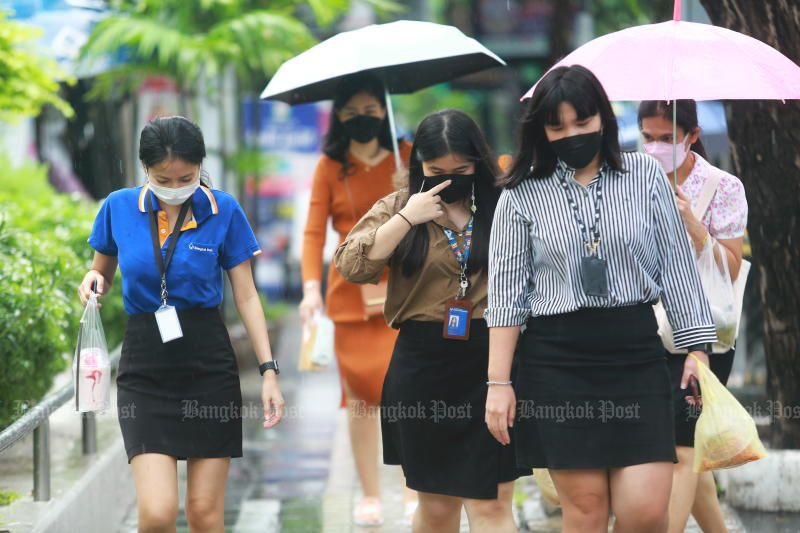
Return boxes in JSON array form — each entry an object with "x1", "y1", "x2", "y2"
[{"x1": 72, "y1": 293, "x2": 111, "y2": 413}]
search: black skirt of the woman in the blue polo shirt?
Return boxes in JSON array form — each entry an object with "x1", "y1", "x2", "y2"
[{"x1": 117, "y1": 308, "x2": 242, "y2": 463}]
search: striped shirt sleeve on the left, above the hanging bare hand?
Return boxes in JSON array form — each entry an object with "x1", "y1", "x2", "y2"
[{"x1": 484, "y1": 189, "x2": 533, "y2": 327}]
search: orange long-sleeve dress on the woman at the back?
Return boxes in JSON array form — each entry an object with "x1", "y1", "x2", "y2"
[{"x1": 301, "y1": 142, "x2": 411, "y2": 406}]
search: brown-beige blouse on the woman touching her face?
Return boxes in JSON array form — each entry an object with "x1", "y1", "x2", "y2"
[{"x1": 334, "y1": 189, "x2": 487, "y2": 328}]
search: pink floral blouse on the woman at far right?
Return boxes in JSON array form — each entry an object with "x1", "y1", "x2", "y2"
[{"x1": 678, "y1": 152, "x2": 747, "y2": 239}]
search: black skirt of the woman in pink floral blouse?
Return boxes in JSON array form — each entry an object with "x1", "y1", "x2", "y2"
[{"x1": 667, "y1": 348, "x2": 735, "y2": 448}]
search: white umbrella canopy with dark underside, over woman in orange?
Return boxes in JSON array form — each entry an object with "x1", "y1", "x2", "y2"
[{"x1": 261, "y1": 20, "x2": 505, "y2": 105}]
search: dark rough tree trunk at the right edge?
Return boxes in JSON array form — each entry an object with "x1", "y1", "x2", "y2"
[{"x1": 701, "y1": 0, "x2": 800, "y2": 448}]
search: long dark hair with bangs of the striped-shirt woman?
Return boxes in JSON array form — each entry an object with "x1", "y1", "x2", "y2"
[{"x1": 503, "y1": 65, "x2": 624, "y2": 188}]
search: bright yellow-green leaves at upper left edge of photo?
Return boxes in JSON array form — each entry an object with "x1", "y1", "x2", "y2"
[{"x1": 0, "y1": 10, "x2": 74, "y2": 121}]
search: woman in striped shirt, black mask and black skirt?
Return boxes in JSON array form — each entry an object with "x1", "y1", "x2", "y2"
[{"x1": 485, "y1": 65, "x2": 716, "y2": 533}]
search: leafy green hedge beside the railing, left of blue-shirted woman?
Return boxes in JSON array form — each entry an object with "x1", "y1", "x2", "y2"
[{"x1": 0, "y1": 159, "x2": 125, "y2": 427}]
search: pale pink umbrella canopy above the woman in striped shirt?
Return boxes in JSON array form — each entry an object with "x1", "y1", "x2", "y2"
[{"x1": 522, "y1": 0, "x2": 800, "y2": 101}]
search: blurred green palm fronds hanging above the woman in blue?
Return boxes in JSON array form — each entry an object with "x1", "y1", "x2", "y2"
[{"x1": 82, "y1": 0, "x2": 402, "y2": 97}]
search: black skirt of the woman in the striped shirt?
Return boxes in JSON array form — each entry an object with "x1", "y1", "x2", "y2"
[{"x1": 514, "y1": 304, "x2": 677, "y2": 469}]
